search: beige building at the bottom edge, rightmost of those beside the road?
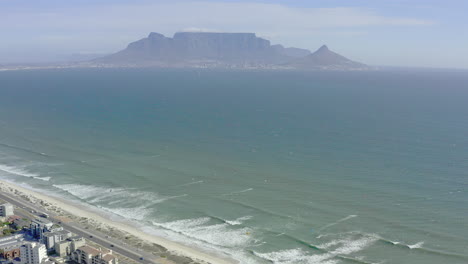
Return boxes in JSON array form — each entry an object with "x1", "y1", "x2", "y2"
[{"x1": 71, "y1": 246, "x2": 119, "y2": 264}]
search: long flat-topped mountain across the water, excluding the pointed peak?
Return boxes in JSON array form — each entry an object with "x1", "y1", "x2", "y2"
[{"x1": 95, "y1": 32, "x2": 310, "y2": 66}]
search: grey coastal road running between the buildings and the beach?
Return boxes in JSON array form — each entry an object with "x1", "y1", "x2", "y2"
[{"x1": 0, "y1": 192, "x2": 157, "y2": 264}]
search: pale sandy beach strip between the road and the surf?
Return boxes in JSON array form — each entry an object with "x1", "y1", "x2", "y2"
[{"x1": 0, "y1": 180, "x2": 238, "y2": 264}]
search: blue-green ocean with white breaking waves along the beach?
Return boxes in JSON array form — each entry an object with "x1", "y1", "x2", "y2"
[{"x1": 0, "y1": 69, "x2": 468, "y2": 264}]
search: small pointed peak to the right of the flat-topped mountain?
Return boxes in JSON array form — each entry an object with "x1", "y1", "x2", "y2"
[{"x1": 287, "y1": 45, "x2": 368, "y2": 70}]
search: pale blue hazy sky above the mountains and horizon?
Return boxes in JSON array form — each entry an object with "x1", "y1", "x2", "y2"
[{"x1": 0, "y1": 0, "x2": 468, "y2": 69}]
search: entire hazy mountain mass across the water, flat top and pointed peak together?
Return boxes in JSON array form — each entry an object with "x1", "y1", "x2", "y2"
[{"x1": 93, "y1": 32, "x2": 363, "y2": 69}]
